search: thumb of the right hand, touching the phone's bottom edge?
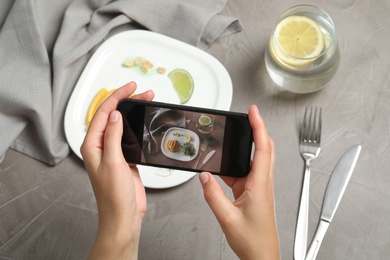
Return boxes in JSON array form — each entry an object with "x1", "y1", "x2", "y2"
[{"x1": 199, "y1": 172, "x2": 234, "y2": 224}]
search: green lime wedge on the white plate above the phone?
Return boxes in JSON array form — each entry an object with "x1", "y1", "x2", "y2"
[{"x1": 168, "y1": 69, "x2": 194, "y2": 104}]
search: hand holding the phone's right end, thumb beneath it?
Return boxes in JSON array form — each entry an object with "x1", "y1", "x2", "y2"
[{"x1": 199, "y1": 105, "x2": 280, "y2": 260}]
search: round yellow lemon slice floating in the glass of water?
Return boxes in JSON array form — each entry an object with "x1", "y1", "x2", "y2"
[{"x1": 271, "y1": 15, "x2": 324, "y2": 67}]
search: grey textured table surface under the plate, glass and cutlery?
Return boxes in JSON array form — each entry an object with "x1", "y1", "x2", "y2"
[{"x1": 0, "y1": 0, "x2": 390, "y2": 259}]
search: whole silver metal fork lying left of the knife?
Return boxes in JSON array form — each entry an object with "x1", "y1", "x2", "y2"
[{"x1": 294, "y1": 107, "x2": 322, "y2": 260}]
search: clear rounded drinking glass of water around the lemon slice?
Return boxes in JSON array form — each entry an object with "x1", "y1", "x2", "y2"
[{"x1": 265, "y1": 5, "x2": 340, "y2": 93}]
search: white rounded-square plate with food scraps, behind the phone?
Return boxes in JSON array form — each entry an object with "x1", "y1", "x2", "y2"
[{"x1": 64, "y1": 30, "x2": 233, "y2": 189}]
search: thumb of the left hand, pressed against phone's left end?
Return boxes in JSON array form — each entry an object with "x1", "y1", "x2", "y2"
[{"x1": 103, "y1": 110, "x2": 123, "y2": 161}]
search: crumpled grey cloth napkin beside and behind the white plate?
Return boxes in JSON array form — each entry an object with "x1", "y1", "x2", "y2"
[{"x1": 0, "y1": 0, "x2": 241, "y2": 165}]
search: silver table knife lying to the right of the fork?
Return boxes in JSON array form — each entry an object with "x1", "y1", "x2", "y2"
[{"x1": 305, "y1": 145, "x2": 361, "y2": 260}]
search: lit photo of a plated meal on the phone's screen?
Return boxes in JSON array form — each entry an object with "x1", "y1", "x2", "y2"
[{"x1": 141, "y1": 106, "x2": 226, "y2": 172}]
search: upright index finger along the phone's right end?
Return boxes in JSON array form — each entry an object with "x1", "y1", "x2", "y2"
[{"x1": 248, "y1": 105, "x2": 274, "y2": 187}]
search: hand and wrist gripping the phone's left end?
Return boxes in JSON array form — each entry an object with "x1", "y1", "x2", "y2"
[{"x1": 81, "y1": 82, "x2": 154, "y2": 259}]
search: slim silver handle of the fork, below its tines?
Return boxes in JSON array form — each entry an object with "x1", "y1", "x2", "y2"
[{"x1": 294, "y1": 160, "x2": 310, "y2": 260}]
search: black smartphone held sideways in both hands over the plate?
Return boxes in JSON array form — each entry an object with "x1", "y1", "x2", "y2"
[{"x1": 118, "y1": 99, "x2": 253, "y2": 177}]
